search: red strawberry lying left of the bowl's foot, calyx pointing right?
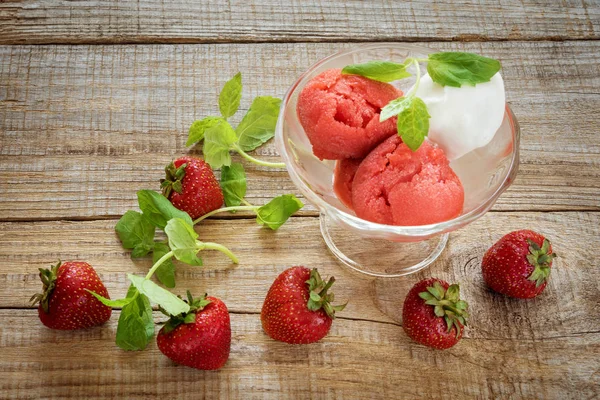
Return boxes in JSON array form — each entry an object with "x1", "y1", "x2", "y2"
[{"x1": 260, "y1": 267, "x2": 346, "y2": 344}]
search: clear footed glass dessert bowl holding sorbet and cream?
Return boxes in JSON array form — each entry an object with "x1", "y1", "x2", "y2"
[{"x1": 275, "y1": 43, "x2": 519, "y2": 277}]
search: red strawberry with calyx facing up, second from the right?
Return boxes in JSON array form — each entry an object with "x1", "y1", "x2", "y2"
[{"x1": 402, "y1": 278, "x2": 469, "y2": 349}]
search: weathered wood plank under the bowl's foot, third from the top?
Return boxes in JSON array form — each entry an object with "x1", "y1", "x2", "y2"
[{"x1": 0, "y1": 212, "x2": 600, "y2": 340}]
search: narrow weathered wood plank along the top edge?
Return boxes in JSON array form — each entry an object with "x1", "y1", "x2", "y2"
[{"x1": 0, "y1": 0, "x2": 600, "y2": 44}]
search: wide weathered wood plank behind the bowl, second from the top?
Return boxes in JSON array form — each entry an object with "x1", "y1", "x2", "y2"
[{"x1": 0, "y1": 41, "x2": 600, "y2": 221}]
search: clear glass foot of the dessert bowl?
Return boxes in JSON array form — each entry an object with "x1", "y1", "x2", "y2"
[{"x1": 320, "y1": 213, "x2": 448, "y2": 278}]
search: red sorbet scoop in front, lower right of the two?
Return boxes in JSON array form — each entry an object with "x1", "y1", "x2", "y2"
[{"x1": 352, "y1": 135, "x2": 465, "y2": 225}]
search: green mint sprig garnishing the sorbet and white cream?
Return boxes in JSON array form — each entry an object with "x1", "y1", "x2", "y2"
[{"x1": 342, "y1": 52, "x2": 500, "y2": 151}]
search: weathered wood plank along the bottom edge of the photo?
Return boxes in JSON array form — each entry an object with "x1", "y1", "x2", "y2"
[{"x1": 0, "y1": 310, "x2": 600, "y2": 400}]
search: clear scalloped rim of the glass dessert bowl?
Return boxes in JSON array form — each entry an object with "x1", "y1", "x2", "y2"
[{"x1": 275, "y1": 43, "x2": 520, "y2": 240}]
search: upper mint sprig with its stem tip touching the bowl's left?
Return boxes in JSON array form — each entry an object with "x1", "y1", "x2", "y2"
[{"x1": 186, "y1": 73, "x2": 285, "y2": 168}]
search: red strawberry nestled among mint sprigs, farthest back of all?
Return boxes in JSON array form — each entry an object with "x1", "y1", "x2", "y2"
[{"x1": 160, "y1": 157, "x2": 223, "y2": 219}]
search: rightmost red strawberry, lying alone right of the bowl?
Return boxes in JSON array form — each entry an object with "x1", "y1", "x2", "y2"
[{"x1": 481, "y1": 230, "x2": 556, "y2": 299}]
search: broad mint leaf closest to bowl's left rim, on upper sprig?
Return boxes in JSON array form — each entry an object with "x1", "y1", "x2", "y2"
[{"x1": 235, "y1": 96, "x2": 281, "y2": 151}]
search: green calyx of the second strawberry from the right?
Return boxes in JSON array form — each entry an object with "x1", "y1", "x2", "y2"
[{"x1": 419, "y1": 282, "x2": 469, "y2": 338}]
